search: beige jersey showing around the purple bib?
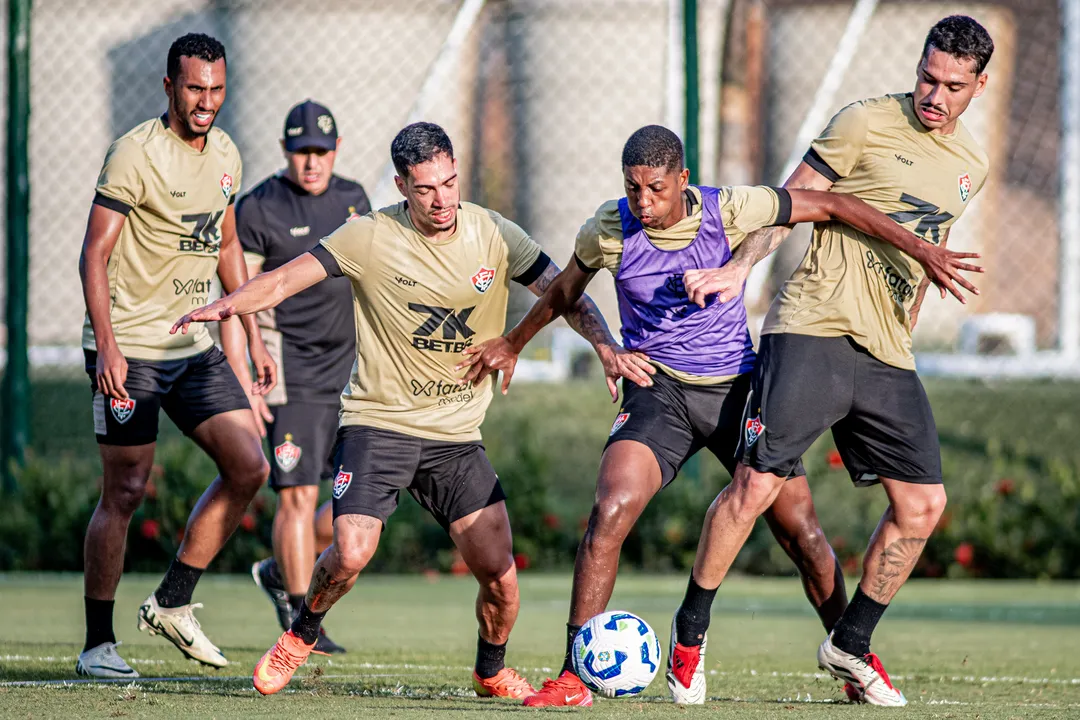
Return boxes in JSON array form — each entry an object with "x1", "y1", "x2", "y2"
[{"x1": 573, "y1": 186, "x2": 780, "y2": 385}]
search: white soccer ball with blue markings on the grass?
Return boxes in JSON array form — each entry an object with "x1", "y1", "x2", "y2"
[{"x1": 571, "y1": 611, "x2": 660, "y2": 697}]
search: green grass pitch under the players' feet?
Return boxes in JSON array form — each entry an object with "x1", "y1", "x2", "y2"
[{"x1": 0, "y1": 574, "x2": 1080, "y2": 720}]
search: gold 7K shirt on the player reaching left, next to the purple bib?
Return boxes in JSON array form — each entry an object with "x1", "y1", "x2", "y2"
[{"x1": 314, "y1": 203, "x2": 546, "y2": 443}]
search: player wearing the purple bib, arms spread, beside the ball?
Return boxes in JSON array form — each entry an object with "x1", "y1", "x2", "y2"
[{"x1": 461, "y1": 125, "x2": 980, "y2": 707}]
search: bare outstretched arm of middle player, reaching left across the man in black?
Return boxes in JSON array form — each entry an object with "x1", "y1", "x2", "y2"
[{"x1": 170, "y1": 253, "x2": 326, "y2": 334}]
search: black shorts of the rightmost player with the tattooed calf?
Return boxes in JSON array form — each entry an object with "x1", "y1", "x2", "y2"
[{"x1": 742, "y1": 332, "x2": 942, "y2": 486}]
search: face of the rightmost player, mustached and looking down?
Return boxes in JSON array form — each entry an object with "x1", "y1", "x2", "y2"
[{"x1": 914, "y1": 46, "x2": 986, "y2": 135}]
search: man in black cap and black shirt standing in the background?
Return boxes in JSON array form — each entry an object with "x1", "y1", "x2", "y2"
[{"x1": 237, "y1": 100, "x2": 372, "y2": 654}]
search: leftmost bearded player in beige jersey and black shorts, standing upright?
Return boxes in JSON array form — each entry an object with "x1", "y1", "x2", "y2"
[{"x1": 76, "y1": 35, "x2": 276, "y2": 678}]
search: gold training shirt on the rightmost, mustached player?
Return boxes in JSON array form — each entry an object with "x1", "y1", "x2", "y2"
[{"x1": 761, "y1": 94, "x2": 989, "y2": 370}]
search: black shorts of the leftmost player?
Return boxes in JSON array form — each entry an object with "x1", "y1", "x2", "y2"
[{"x1": 83, "y1": 348, "x2": 252, "y2": 446}]
